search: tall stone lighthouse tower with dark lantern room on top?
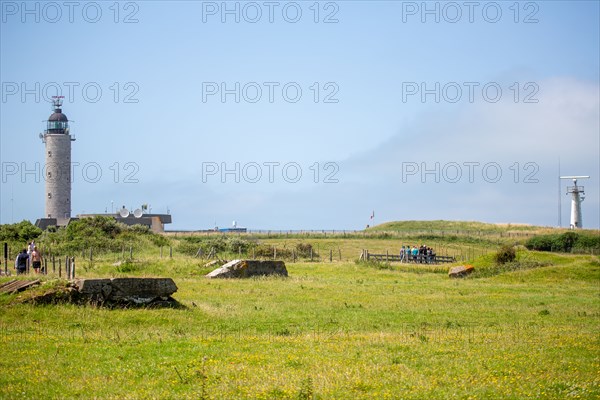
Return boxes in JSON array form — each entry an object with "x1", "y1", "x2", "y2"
[{"x1": 40, "y1": 96, "x2": 75, "y2": 226}]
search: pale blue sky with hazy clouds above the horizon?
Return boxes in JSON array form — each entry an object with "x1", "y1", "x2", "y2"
[{"x1": 0, "y1": 1, "x2": 600, "y2": 229}]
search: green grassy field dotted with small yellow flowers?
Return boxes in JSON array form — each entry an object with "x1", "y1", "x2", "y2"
[{"x1": 0, "y1": 228, "x2": 600, "y2": 399}]
